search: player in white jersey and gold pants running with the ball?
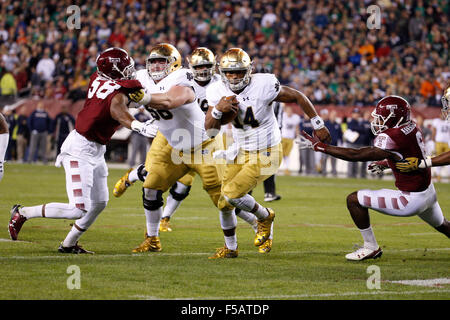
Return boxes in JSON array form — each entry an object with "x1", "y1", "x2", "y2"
[{"x1": 205, "y1": 48, "x2": 331, "y2": 254}]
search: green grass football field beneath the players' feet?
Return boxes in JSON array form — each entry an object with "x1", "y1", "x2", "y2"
[{"x1": 0, "y1": 163, "x2": 450, "y2": 300}]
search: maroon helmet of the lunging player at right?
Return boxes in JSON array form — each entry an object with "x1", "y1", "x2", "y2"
[{"x1": 370, "y1": 95, "x2": 411, "y2": 135}]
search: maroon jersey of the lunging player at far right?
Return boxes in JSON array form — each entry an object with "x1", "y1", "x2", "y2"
[{"x1": 374, "y1": 122, "x2": 431, "y2": 192}]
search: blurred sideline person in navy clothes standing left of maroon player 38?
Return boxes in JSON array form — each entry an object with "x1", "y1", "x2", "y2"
[{"x1": 27, "y1": 101, "x2": 52, "y2": 164}]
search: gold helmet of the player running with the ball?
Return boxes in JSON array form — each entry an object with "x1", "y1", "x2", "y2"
[{"x1": 219, "y1": 48, "x2": 252, "y2": 91}]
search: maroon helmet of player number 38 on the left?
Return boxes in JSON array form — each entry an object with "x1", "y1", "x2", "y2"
[{"x1": 96, "y1": 47, "x2": 136, "y2": 80}]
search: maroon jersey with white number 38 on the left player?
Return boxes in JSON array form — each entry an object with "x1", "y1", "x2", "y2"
[{"x1": 75, "y1": 72, "x2": 142, "y2": 144}]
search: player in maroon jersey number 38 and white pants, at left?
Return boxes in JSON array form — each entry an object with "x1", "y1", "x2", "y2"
[{"x1": 8, "y1": 47, "x2": 157, "y2": 253}]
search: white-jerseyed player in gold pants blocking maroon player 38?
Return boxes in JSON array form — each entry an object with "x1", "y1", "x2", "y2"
[{"x1": 125, "y1": 43, "x2": 244, "y2": 258}]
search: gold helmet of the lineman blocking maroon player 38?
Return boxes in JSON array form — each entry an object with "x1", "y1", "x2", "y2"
[{"x1": 146, "y1": 43, "x2": 181, "y2": 81}]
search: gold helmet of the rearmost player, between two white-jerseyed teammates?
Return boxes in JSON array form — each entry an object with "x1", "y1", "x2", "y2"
[{"x1": 187, "y1": 47, "x2": 216, "y2": 81}]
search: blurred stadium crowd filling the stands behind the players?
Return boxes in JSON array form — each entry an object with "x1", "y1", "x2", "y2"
[{"x1": 0, "y1": 0, "x2": 450, "y2": 106}]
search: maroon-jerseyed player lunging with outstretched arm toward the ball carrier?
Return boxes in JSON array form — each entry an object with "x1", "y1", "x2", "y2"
[{"x1": 302, "y1": 95, "x2": 450, "y2": 260}]
